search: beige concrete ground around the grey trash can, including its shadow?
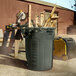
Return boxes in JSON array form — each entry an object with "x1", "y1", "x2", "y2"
[{"x1": 0, "y1": 47, "x2": 76, "y2": 76}]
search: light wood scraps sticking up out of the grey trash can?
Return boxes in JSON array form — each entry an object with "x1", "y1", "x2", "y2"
[{"x1": 28, "y1": 5, "x2": 59, "y2": 27}]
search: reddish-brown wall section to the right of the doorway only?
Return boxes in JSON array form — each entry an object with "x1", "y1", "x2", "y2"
[{"x1": 58, "y1": 10, "x2": 74, "y2": 34}]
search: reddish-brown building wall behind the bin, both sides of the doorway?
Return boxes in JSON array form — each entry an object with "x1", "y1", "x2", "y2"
[{"x1": 0, "y1": 0, "x2": 74, "y2": 34}]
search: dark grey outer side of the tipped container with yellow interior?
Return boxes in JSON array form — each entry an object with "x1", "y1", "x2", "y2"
[{"x1": 63, "y1": 38, "x2": 76, "y2": 59}]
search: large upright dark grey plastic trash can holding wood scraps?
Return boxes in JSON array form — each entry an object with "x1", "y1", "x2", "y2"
[{"x1": 25, "y1": 28, "x2": 55, "y2": 71}]
